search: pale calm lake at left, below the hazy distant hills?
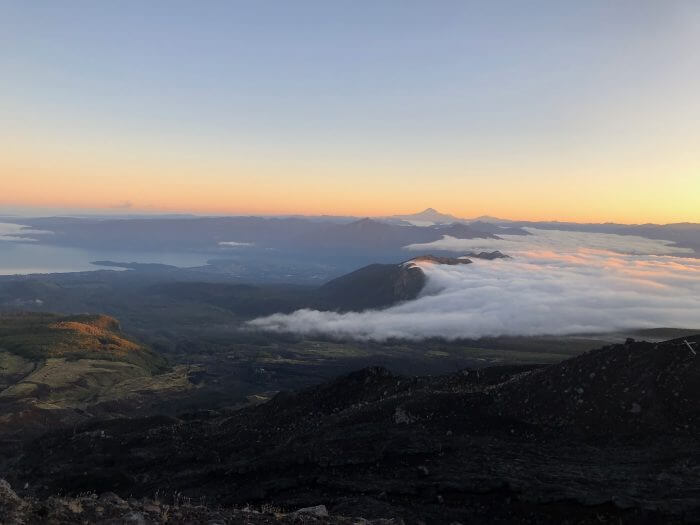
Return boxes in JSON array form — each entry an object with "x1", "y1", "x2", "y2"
[{"x1": 0, "y1": 240, "x2": 211, "y2": 275}]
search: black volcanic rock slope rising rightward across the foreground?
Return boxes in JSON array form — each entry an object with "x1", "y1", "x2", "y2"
[{"x1": 8, "y1": 338, "x2": 700, "y2": 523}]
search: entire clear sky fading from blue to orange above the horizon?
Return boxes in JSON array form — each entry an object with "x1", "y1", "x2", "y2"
[{"x1": 0, "y1": 0, "x2": 700, "y2": 223}]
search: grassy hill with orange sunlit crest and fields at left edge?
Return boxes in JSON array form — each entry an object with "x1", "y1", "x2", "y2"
[{"x1": 0, "y1": 313, "x2": 192, "y2": 435}]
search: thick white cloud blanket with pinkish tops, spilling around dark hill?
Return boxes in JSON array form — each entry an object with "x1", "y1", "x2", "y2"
[{"x1": 249, "y1": 229, "x2": 700, "y2": 341}]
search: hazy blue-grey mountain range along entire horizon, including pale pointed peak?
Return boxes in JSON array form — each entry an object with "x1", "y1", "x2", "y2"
[{"x1": 8, "y1": 209, "x2": 700, "y2": 260}]
